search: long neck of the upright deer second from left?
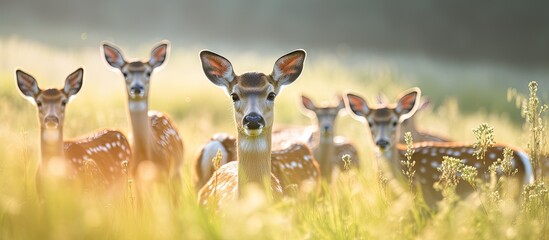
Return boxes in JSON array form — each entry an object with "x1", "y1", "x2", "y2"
[{"x1": 129, "y1": 100, "x2": 152, "y2": 166}]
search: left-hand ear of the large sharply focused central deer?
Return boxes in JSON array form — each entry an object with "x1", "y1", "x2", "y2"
[{"x1": 200, "y1": 50, "x2": 236, "y2": 88}]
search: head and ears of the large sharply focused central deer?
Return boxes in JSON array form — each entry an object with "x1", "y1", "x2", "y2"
[{"x1": 200, "y1": 50, "x2": 305, "y2": 140}]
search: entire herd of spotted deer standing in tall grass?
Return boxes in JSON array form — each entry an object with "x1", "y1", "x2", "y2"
[{"x1": 16, "y1": 42, "x2": 533, "y2": 209}]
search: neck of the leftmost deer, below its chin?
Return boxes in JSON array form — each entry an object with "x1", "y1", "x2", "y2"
[{"x1": 40, "y1": 127, "x2": 65, "y2": 163}]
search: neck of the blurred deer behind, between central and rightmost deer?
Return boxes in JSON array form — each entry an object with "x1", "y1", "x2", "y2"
[{"x1": 315, "y1": 132, "x2": 335, "y2": 181}]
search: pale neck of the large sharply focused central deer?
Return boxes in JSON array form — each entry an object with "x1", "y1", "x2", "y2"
[{"x1": 237, "y1": 127, "x2": 272, "y2": 196}]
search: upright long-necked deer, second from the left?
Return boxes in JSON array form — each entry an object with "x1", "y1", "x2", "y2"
[{"x1": 102, "y1": 41, "x2": 184, "y2": 191}]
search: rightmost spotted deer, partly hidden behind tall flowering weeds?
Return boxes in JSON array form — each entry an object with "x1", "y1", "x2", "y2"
[{"x1": 344, "y1": 88, "x2": 533, "y2": 207}]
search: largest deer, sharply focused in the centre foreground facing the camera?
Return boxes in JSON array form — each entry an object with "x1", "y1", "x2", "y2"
[{"x1": 198, "y1": 50, "x2": 320, "y2": 206}]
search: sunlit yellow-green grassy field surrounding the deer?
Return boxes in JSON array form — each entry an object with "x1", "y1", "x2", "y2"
[{"x1": 0, "y1": 39, "x2": 549, "y2": 239}]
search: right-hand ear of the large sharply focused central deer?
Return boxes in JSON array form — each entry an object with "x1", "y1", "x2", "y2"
[{"x1": 271, "y1": 49, "x2": 306, "y2": 87}]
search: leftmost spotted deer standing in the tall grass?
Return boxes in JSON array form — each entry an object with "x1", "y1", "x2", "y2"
[{"x1": 16, "y1": 68, "x2": 131, "y2": 196}]
